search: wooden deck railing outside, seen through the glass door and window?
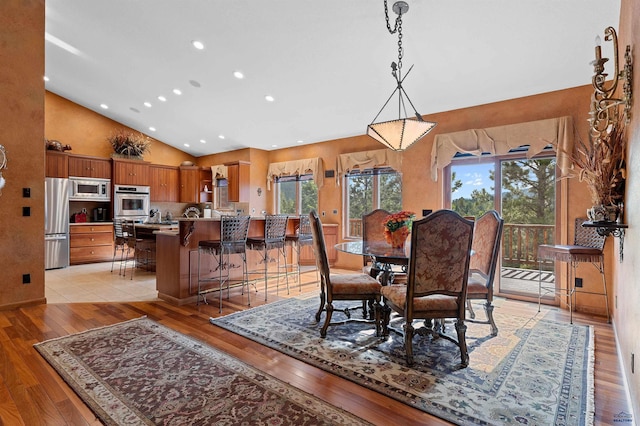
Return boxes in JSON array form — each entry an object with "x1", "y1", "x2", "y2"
[{"x1": 349, "y1": 219, "x2": 555, "y2": 269}]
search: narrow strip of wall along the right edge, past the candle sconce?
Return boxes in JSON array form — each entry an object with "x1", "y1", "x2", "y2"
[{"x1": 612, "y1": 0, "x2": 640, "y2": 423}]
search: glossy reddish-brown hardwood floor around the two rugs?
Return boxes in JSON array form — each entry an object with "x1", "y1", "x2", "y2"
[{"x1": 0, "y1": 263, "x2": 630, "y2": 426}]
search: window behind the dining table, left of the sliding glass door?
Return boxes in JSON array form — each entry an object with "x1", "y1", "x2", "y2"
[{"x1": 344, "y1": 168, "x2": 402, "y2": 238}]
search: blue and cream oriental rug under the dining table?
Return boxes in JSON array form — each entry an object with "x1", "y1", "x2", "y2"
[{"x1": 210, "y1": 298, "x2": 594, "y2": 425}]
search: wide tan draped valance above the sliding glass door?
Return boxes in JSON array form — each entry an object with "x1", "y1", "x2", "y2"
[{"x1": 431, "y1": 116, "x2": 573, "y2": 181}]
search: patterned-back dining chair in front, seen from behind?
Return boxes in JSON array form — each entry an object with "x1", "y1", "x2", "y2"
[{"x1": 381, "y1": 210, "x2": 473, "y2": 367}]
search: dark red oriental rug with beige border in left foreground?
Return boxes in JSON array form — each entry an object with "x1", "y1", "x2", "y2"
[{"x1": 34, "y1": 318, "x2": 368, "y2": 425}]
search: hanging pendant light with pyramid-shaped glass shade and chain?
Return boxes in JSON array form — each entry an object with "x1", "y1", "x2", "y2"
[{"x1": 367, "y1": 0, "x2": 436, "y2": 151}]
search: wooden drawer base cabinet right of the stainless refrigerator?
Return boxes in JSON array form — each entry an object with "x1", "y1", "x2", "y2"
[{"x1": 69, "y1": 223, "x2": 113, "y2": 265}]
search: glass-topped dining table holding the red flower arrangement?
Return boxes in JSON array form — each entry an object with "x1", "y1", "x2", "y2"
[{"x1": 335, "y1": 240, "x2": 411, "y2": 285}]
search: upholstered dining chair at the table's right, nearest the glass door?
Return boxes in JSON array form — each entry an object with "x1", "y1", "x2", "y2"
[{"x1": 467, "y1": 210, "x2": 504, "y2": 336}]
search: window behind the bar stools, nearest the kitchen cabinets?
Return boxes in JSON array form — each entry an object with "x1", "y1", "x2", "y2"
[{"x1": 275, "y1": 175, "x2": 318, "y2": 215}]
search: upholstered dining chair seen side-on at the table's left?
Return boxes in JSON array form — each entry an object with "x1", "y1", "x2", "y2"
[{"x1": 309, "y1": 210, "x2": 382, "y2": 337}]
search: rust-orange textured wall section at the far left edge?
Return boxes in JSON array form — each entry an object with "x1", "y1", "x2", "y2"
[{"x1": 0, "y1": 0, "x2": 44, "y2": 307}]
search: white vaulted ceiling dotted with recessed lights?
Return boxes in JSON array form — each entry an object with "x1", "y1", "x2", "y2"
[{"x1": 45, "y1": 0, "x2": 620, "y2": 156}]
